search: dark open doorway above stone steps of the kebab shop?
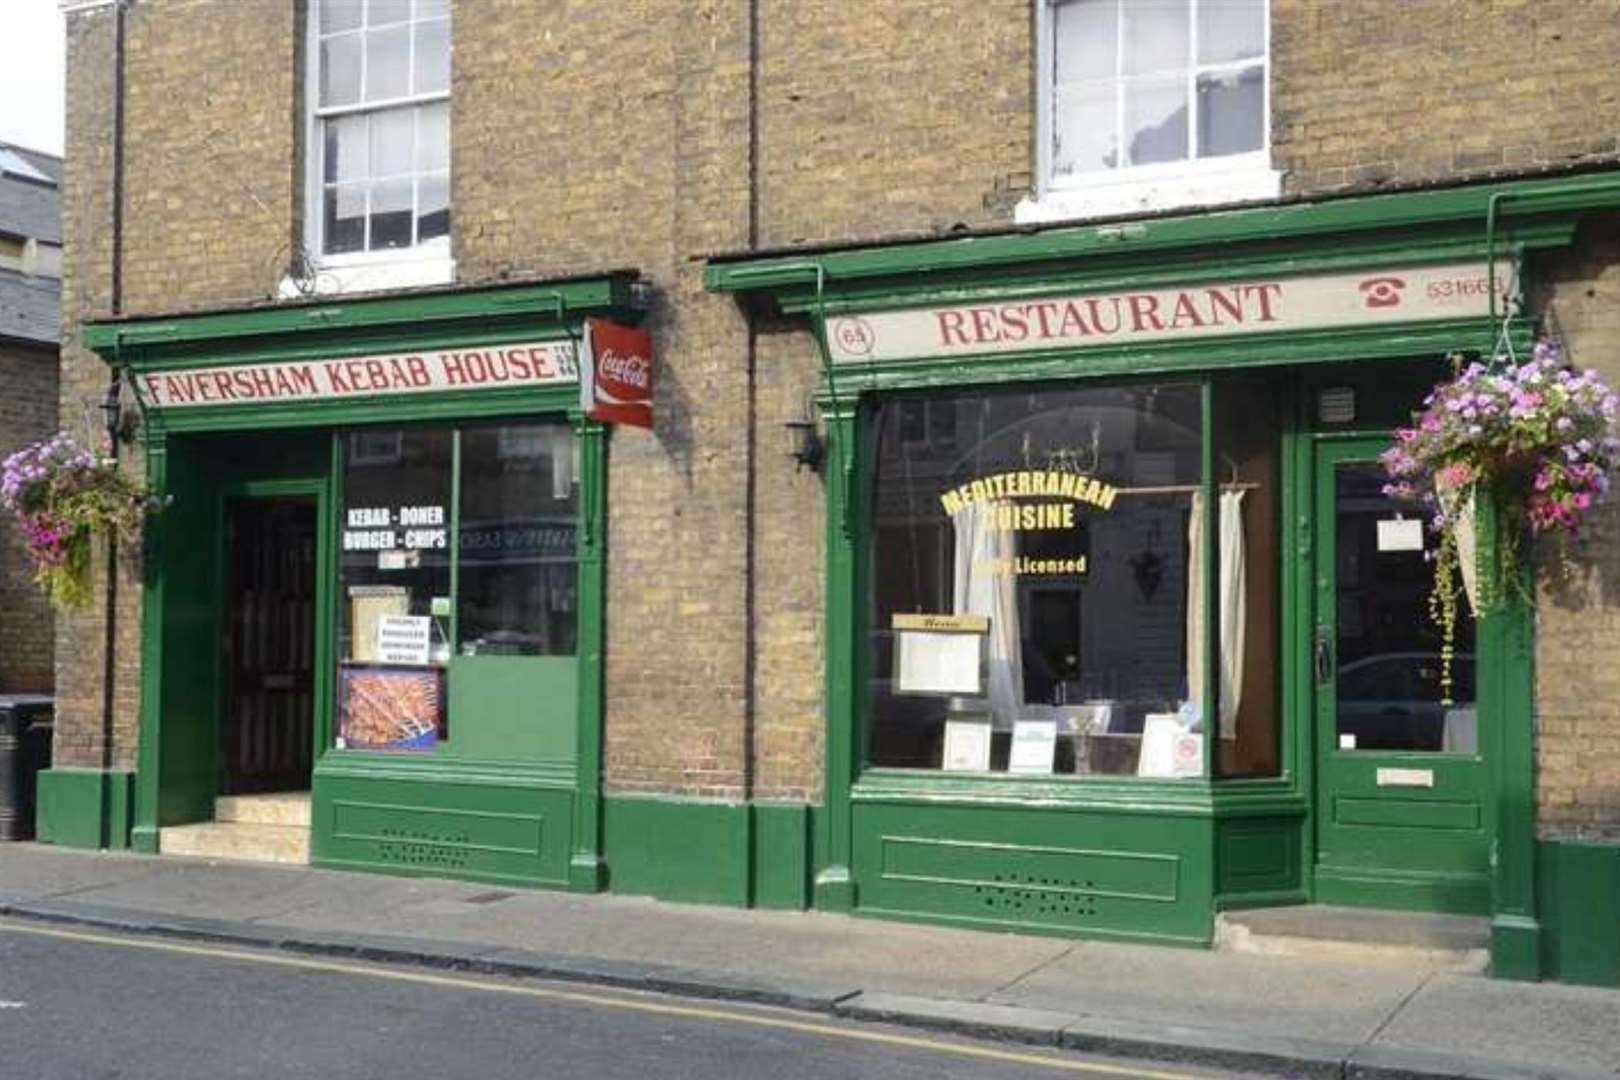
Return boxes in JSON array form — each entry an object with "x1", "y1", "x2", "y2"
[{"x1": 220, "y1": 499, "x2": 316, "y2": 795}]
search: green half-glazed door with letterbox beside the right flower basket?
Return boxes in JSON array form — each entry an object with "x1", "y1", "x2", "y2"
[{"x1": 1312, "y1": 439, "x2": 1492, "y2": 913}]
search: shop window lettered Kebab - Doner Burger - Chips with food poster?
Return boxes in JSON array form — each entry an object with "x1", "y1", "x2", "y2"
[{"x1": 337, "y1": 421, "x2": 578, "y2": 756}]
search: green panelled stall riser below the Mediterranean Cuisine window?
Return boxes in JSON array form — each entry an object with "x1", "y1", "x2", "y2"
[{"x1": 854, "y1": 801, "x2": 1213, "y2": 944}]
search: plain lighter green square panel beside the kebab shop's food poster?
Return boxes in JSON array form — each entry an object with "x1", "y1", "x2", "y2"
[{"x1": 436, "y1": 656, "x2": 580, "y2": 761}]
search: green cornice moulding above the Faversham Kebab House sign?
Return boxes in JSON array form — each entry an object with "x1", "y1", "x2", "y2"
[{"x1": 79, "y1": 270, "x2": 642, "y2": 362}]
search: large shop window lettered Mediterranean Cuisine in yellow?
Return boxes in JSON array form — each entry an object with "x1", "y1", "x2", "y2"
[{"x1": 865, "y1": 384, "x2": 1224, "y2": 777}]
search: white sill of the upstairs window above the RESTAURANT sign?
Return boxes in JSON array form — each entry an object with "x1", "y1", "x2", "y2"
[{"x1": 1013, "y1": 165, "x2": 1283, "y2": 225}]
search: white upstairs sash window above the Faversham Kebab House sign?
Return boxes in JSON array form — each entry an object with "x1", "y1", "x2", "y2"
[{"x1": 306, "y1": 0, "x2": 450, "y2": 283}]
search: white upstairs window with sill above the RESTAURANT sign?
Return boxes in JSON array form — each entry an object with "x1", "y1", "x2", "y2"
[{"x1": 1021, "y1": 0, "x2": 1280, "y2": 220}]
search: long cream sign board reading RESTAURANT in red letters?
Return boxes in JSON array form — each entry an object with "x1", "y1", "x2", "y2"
[{"x1": 826, "y1": 262, "x2": 1516, "y2": 364}]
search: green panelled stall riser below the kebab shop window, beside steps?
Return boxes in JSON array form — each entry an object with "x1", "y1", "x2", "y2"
[{"x1": 311, "y1": 767, "x2": 573, "y2": 886}]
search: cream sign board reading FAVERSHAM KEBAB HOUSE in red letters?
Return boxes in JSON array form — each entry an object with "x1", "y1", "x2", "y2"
[{"x1": 136, "y1": 342, "x2": 578, "y2": 410}]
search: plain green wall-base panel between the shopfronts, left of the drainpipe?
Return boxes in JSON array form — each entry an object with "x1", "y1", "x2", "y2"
[{"x1": 603, "y1": 795, "x2": 750, "y2": 907}]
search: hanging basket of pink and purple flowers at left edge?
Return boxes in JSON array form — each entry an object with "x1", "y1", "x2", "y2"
[{"x1": 0, "y1": 434, "x2": 157, "y2": 610}]
